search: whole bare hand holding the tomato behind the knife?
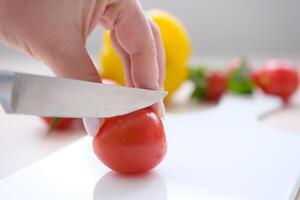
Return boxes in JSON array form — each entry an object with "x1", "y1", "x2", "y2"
[{"x1": 0, "y1": 0, "x2": 165, "y2": 136}]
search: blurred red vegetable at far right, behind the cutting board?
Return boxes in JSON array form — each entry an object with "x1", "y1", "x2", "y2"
[{"x1": 253, "y1": 60, "x2": 299, "y2": 102}]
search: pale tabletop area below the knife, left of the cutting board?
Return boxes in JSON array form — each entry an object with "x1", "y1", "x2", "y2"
[{"x1": 0, "y1": 107, "x2": 85, "y2": 179}]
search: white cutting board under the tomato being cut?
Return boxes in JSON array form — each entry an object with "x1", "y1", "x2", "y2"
[{"x1": 0, "y1": 96, "x2": 300, "y2": 200}]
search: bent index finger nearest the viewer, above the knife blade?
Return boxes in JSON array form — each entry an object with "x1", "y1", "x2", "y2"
[{"x1": 104, "y1": 0, "x2": 160, "y2": 90}]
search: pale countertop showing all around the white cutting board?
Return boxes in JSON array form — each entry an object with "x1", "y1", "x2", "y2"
[{"x1": 0, "y1": 54, "x2": 300, "y2": 200}]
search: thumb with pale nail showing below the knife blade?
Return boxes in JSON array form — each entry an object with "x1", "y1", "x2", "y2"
[{"x1": 42, "y1": 38, "x2": 103, "y2": 136}]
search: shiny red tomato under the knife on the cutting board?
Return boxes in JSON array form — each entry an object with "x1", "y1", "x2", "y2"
[{"x1": 93, "y1": 108, "x2": 167, "y2": 173}]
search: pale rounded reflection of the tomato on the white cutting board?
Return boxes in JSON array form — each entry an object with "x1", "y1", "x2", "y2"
[{"x1": 93, "y1": 171, "x2": 167, "y2": 200}]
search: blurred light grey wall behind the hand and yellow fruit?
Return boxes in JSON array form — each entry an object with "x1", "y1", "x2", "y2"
[{"x1": 0, "y1": 0, "x2": 300, "y2": 62}]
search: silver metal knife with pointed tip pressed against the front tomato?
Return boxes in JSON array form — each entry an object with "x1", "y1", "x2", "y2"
[{"x1": 0, "y1": 71, "x2": 167, "y2": 118}]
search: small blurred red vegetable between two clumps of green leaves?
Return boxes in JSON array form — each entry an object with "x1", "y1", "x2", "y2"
[{"x1": 206, "y1": 72, "x2": 226, "y2": 101}]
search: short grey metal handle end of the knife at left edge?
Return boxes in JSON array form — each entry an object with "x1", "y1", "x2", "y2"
[{"x1": 0, "y1": 71, "x2": 16, "y2": 113}]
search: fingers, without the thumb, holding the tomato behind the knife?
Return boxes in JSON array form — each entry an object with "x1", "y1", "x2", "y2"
[{"x1": 100, "y1": 0, "x2": 165, "y2": 115}]
